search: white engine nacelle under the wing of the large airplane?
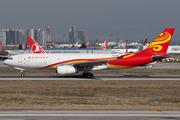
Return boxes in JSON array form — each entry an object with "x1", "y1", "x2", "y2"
[{"x1": 56, "y1": 65, "x2": 78, "y2": 75}]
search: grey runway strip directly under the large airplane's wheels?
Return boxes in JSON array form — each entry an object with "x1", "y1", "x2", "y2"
[{"x1": 0, "y1": 75, "x2": 180, "y2": 81}]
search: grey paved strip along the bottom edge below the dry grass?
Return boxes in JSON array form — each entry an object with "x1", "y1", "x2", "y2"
[{"x1": 0, "y1": 110, "x2": 180, "y2": 120}]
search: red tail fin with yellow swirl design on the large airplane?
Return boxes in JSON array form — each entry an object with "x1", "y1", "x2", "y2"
[{"x1": 138, "y1": 28, "x2": 175, "y2": 55}]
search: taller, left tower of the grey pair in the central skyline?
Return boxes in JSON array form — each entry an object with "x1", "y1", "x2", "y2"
[{"x1": 69, "y1": 25, "x2": 77, "y2": 43}]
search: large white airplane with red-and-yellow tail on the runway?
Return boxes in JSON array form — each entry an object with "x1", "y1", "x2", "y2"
[{"x1": 3, "y1": 28, "x2": 175, "y2": 78}]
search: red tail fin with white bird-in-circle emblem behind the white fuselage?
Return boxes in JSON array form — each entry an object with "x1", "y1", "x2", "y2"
[{"x1": 27, "y1": 37, "x2": 46, "y2": 53}]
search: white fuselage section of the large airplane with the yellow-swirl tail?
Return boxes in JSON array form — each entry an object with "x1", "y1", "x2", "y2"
[{"x1": 4, "y1": 53, "x2": 120, "y2": 70}]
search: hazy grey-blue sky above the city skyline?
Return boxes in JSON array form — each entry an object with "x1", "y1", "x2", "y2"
[{"x1": 0, "y1": 0, "x2": 180, "y2": 42}]
